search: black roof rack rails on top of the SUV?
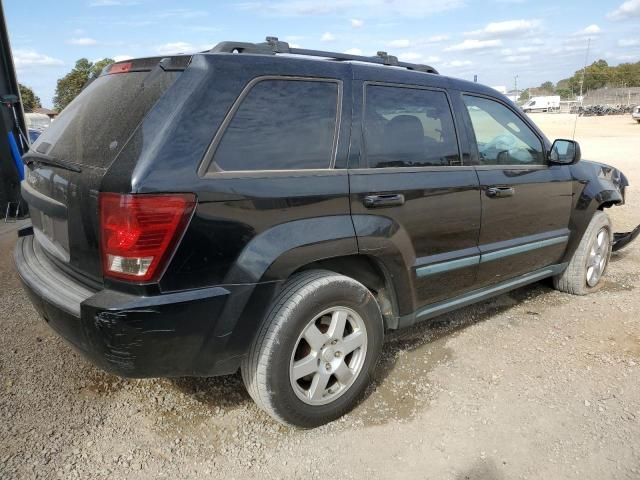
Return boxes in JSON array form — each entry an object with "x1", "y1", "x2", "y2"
[{"x1": 209, "y1": 37, "x2": 438, "y2": 74}]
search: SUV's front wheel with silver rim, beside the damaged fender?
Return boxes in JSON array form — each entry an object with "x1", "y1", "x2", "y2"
[{"x1": 553, "y1": 210, "x2": 613, "y2": 295}]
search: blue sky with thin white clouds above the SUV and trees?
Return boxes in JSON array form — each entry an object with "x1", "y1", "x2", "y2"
[{"x1": 4, "y1": 0, "x2": 640, "y2": 106}]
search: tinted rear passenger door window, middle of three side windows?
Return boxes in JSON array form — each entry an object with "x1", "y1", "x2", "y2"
[{"x1": 364, "y1": 85, "x2": 461, "y2": 168}]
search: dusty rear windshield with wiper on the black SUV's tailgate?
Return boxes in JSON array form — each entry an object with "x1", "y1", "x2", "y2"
[{"x1": 34, "y1": 70, "x2": 180, "y2": 168}]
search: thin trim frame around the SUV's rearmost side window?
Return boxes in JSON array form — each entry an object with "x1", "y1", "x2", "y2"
[{"x1": 197, "y1": 75, "x2": 343, "y2": 174}]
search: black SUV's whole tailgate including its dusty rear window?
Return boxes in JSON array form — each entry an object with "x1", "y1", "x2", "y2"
[{"x1": 22, "y1": 57, "x2": 189, "y2": 282}]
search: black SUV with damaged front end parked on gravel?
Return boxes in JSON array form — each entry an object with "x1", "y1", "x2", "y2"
[{"x1": 15, "y1": 38, "x2": 638, "y2": 427}]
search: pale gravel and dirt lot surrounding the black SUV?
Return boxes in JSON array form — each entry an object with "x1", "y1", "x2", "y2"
[{"x1": 0, "y1": 114, "x2": 640, "y2": 480}]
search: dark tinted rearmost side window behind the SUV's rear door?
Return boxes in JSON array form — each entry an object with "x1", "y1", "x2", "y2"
[{"x1": 208, "y1": 78, "x2": 340, "y2": 172}]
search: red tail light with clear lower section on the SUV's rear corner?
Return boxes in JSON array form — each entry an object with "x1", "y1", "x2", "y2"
[{"x1": 99, "y1": 193, "x2": 195, "y2": 282}]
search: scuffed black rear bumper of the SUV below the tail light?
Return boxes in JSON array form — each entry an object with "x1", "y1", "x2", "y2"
[{"x1": 14, "y1": 236, "x2": 272, "y2": 377}]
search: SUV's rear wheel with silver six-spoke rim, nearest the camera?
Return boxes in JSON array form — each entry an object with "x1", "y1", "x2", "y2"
[{"x1": 241, "y1": 270, "x2": 384, "y2": 428}]
